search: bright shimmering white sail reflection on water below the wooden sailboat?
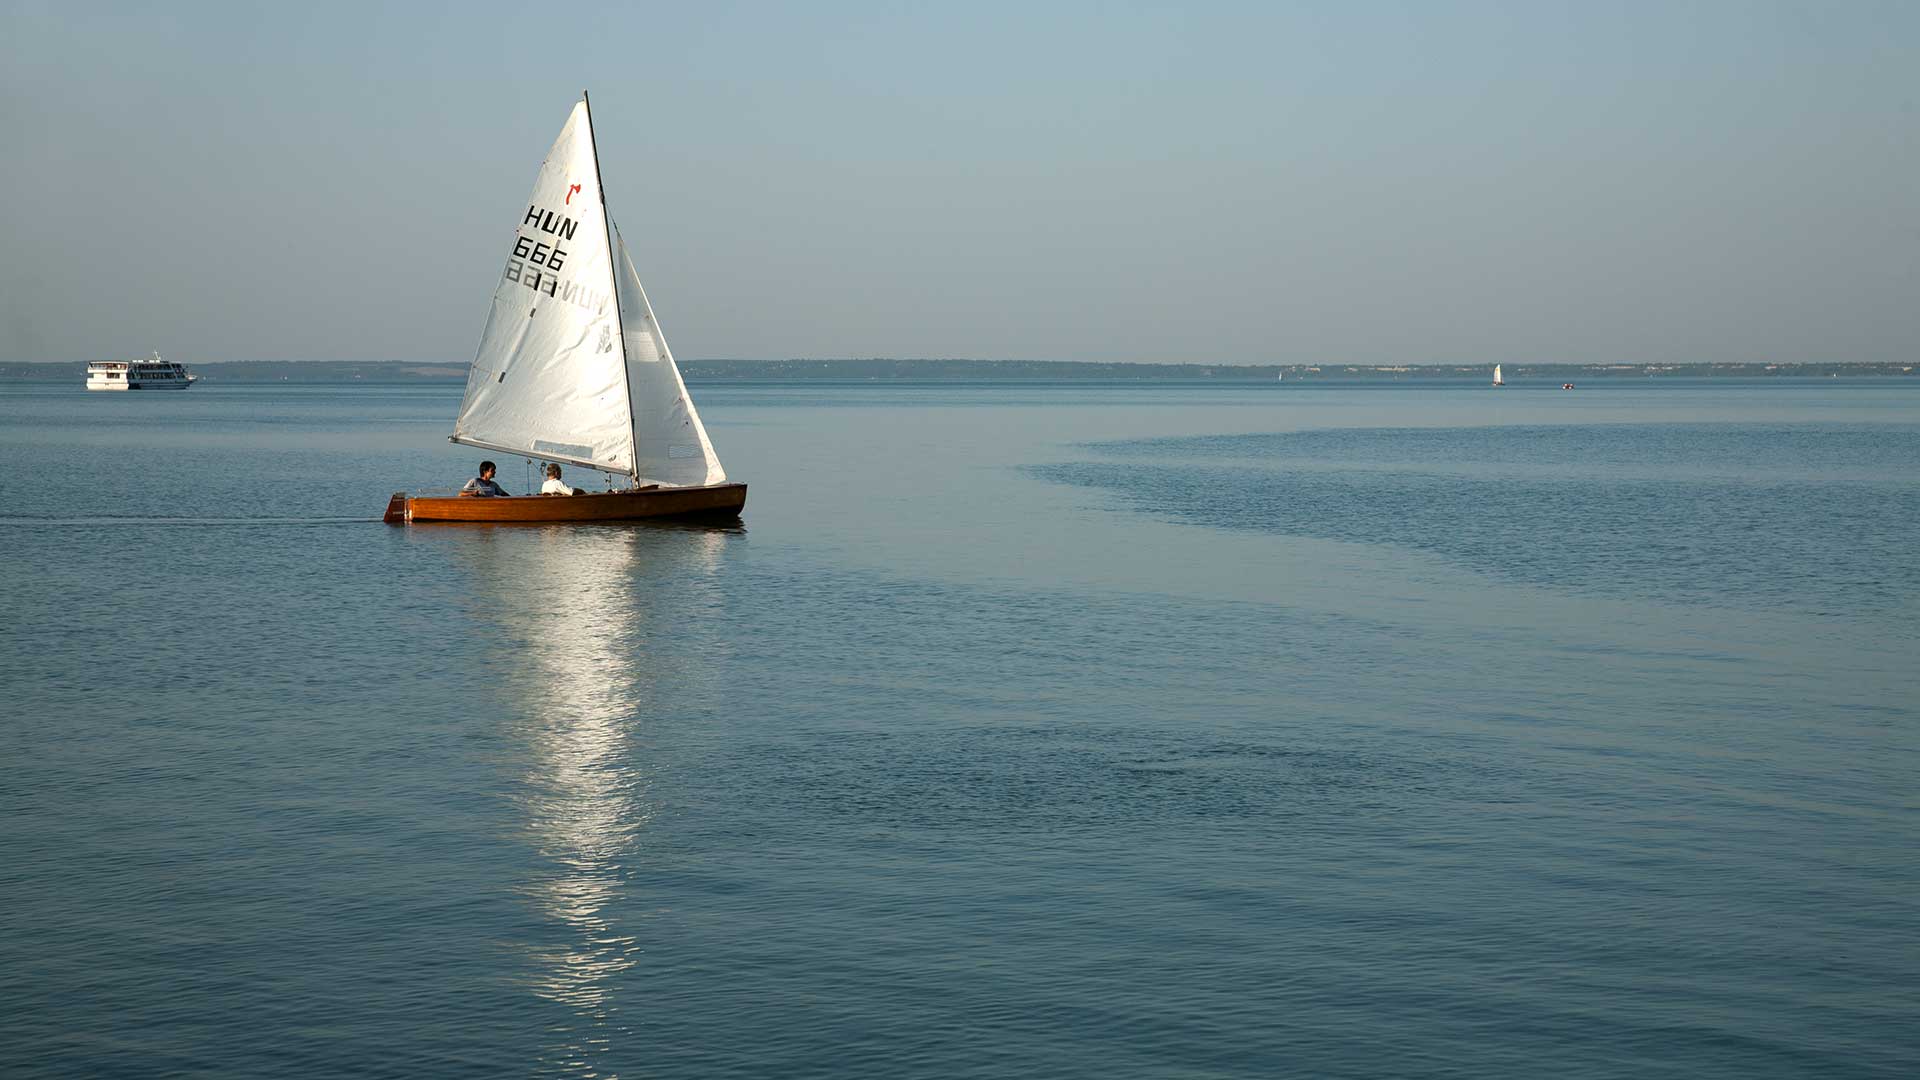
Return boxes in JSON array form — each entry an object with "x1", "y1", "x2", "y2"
[{"x1": 432, "y1": 525, "x2": 739, "y2": 1076}]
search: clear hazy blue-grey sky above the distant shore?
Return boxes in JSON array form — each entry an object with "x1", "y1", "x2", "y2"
[{"x1": 0, "y1": 0, "x2": 1920, "y2": 363}]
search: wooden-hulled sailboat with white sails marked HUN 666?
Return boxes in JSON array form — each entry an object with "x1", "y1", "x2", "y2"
[{"x1": 386, "y1": 94, "x2": 747, "y2": 525}]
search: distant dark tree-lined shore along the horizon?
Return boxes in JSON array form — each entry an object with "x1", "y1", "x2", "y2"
[{"x1": 0, "y1": 359, "x2": 1916, "y2": 382}]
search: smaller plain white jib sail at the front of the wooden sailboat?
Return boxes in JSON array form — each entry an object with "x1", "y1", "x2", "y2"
[{"x1": 614, "y1": 225, "x2": 726, "y2": 484}]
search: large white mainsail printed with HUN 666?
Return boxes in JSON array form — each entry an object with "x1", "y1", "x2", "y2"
[{"x1": 453, "y1": 102, "x2": 629, "y2": 475}]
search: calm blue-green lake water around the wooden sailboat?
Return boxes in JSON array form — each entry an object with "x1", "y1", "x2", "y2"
[{"x1": 0, "y1": 377, "x2": 1920, "y2": 1078}]
